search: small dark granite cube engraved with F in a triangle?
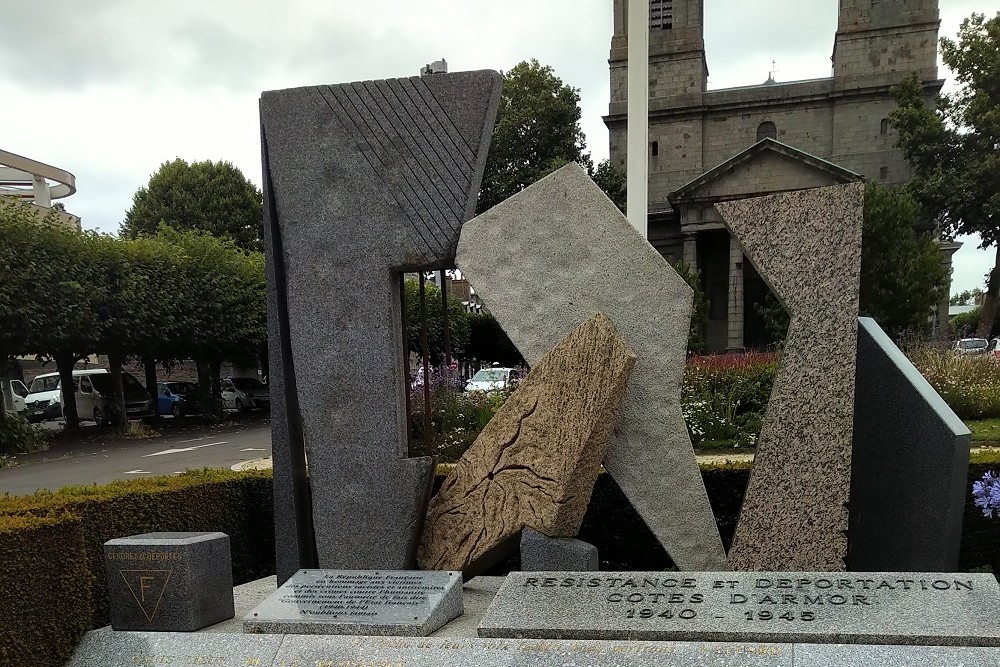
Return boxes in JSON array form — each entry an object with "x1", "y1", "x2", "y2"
[{"x1": 104, "y1": 533, "x2": 234, "y2": 632}]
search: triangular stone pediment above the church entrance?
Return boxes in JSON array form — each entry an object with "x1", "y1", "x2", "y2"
[{"x1": 669, "y1": 139, "x2": 864, "y2": 206}]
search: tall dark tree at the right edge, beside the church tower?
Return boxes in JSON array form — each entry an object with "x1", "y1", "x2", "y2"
[{"x1": 889, "y1": 14, "x2": 1000, "y2": 337}]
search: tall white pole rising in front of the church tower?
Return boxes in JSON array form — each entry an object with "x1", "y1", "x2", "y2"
[{"x1": 625, "y1": 0, "x2": 649, "y2": 238}]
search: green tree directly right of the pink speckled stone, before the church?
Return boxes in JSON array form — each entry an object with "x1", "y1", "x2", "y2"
[{"x1": 861, "y1": 183, "x2": 948, "y2": 338}]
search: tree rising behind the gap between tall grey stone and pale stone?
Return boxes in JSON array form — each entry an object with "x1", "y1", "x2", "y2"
[{"x1": 478, "y1": 60, "x2": 593, "y2": 212}]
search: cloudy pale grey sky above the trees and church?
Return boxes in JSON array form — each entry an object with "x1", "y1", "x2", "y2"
[{"x1": 0, "y1": 0, "x2": 984, "y2": 291}]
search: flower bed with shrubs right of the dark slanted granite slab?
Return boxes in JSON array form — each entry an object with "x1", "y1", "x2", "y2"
[{"x1": 908, "y1": 346, "x2": 1000, "y2": 419}]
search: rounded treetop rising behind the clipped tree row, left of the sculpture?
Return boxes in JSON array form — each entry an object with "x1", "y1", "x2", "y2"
[{"x1": 121, "y1": 158, "x2": 264, "y2": 251}]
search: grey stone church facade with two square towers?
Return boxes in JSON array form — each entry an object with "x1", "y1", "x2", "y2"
[{"x1": 604, "y1": 0, "x2": 950, "y2": 350}]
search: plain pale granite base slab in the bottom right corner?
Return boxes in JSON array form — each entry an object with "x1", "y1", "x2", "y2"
[{"x1": 794, "y1": 644, "x2": 1000, "y2": 667}]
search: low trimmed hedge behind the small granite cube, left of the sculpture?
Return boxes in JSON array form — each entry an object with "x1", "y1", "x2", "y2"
[{"x1": 0, "y1": 470, "x2": 274, "y2": 667}]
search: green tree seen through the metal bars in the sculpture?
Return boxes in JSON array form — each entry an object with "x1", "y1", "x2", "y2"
[{"x1": 403, "y1": 280, "x2": 469, "y2": 365}]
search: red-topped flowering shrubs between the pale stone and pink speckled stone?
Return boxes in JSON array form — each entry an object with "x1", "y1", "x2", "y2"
[{"x1": 681, "y1": 352, "x2": 778, "y2": 448}]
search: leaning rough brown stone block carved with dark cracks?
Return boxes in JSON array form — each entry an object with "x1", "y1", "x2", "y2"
[{"x1": 417, "y1": 314, "x2": 635, "y2": 575}]
